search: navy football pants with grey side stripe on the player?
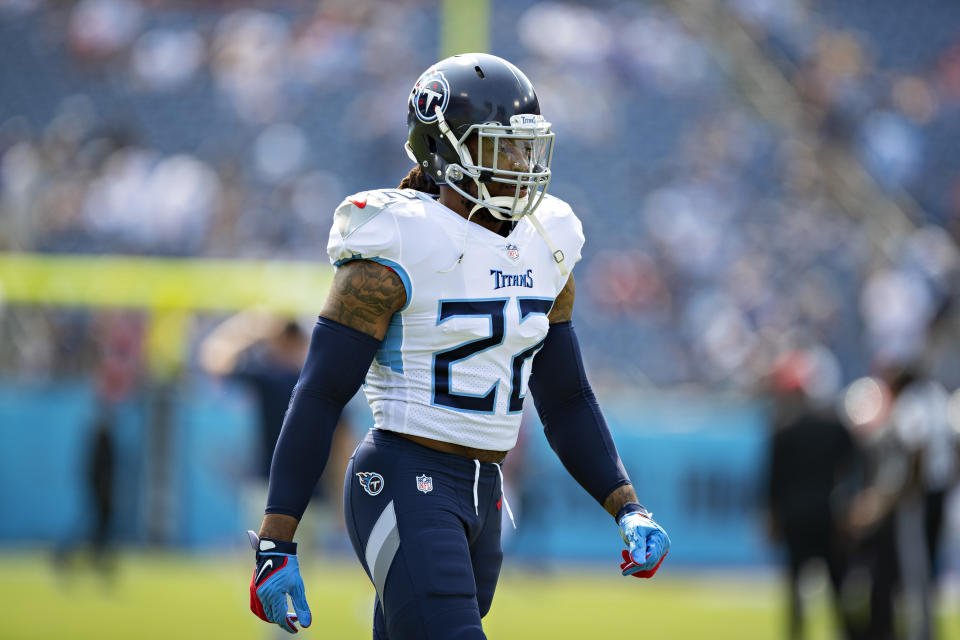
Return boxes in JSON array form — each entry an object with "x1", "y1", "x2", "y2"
[{"x1": 343, "y1": 429, "x2": 503, "y2": 640}]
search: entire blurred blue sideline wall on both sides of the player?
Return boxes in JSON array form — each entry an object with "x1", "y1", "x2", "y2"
[{"x1": 0, "y1": 378, "x2": 770, "y2": 566}]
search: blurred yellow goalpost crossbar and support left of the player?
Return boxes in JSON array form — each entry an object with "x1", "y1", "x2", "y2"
[{"x1": 0, "y1": 253, "x2": 333, "y2": 378}]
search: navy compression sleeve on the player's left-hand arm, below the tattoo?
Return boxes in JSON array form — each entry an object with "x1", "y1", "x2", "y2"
[{"x1": 266, "y1": 317, "x2": 381, "y2": 520}]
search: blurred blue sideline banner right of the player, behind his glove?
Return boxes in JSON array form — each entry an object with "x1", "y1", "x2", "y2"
[{"x1": 504, "y1": 394, "x2": 771, "y2": 566}]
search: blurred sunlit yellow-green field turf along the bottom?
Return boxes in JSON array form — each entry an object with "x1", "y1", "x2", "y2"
[{"x1": 0, "y1": 554, "x2": 960, "y2": 640}]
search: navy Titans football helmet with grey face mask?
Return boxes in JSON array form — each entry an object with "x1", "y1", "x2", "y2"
[{"x1": 405, "y1": 53, "x2": 554, "y2": 220}]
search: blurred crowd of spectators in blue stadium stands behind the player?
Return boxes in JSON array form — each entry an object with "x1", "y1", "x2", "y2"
[{"x1": 0, "y1": 0, "x2": 960, "y2": 393}]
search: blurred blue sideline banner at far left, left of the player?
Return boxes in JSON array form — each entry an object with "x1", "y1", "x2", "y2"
[{"x1": 0, "y1": 380, "x2": 255, "y2": 548}]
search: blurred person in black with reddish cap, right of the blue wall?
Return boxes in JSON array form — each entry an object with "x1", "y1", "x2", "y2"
[{"x1": 768, "y1": 349, "x2": 857, "y2": 640}]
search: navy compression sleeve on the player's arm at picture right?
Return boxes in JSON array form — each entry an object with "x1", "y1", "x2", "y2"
[{"x1": 530, "y1": 322, "x2": 630, "y2": 505}]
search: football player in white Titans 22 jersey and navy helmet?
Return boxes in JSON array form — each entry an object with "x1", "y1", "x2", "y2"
[{"x1": 250, "y1": 54, "x2": 670, "y2": 640}]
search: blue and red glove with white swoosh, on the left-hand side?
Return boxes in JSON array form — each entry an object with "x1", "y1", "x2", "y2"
[{"x1": 247, "y1": 531, "x2": 312, "y2": 633}]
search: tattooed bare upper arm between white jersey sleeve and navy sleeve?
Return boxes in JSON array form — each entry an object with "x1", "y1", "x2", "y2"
[{"x1": 320, "y1": 260, "x2": 407, "y2": 339}]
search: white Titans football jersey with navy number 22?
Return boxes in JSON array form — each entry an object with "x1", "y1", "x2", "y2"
[{"x1": 327, "y1": 189, "x2": 583, "y2": 451}]
